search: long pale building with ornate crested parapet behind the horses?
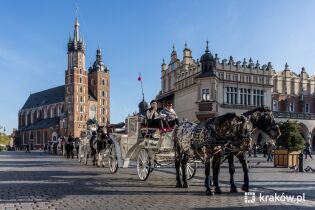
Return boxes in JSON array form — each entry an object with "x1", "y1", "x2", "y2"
[{"x1": 157, "y1": 43, "x2": 315, "y2": 149}]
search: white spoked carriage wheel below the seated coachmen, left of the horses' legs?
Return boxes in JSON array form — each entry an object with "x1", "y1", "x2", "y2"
[{"x1": 137, "y1": 149, "x2": 151, "y2": 181}]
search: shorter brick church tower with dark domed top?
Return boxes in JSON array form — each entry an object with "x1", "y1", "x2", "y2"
[{"x1": 88, "y1": 47, "x2": 110, "y2": 125}]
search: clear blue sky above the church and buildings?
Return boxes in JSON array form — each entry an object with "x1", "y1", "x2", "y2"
[{"x1": 0, "y1": 0, "x2": 315, "y2": 133}]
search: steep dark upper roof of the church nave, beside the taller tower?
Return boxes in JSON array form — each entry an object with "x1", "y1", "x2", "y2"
[{"x1": 22, "y1": 85, "x2": 65, "y2": 109}]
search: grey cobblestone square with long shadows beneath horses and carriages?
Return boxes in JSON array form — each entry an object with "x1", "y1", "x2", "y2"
[{"x1": 0, "y1": 152, "x2": 315, "y2": 210}]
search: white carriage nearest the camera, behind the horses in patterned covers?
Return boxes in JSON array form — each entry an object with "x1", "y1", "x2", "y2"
[{"x1": 112, "y1": 116, "x2": 198, "y2": 181}]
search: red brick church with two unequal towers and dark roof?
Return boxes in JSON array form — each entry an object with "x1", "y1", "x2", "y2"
[{"x1": 17, "y1": 19, "x2": 110, "y2": 147}]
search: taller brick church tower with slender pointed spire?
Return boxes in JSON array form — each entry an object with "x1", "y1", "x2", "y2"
[{"x1": 65, "y1": 18, "x2": 88, "y2": 137}]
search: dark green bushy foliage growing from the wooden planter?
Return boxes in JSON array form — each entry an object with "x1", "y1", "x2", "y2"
[{"x1": 276, "y1": 120, "x2": 305, "y2": 150}]
